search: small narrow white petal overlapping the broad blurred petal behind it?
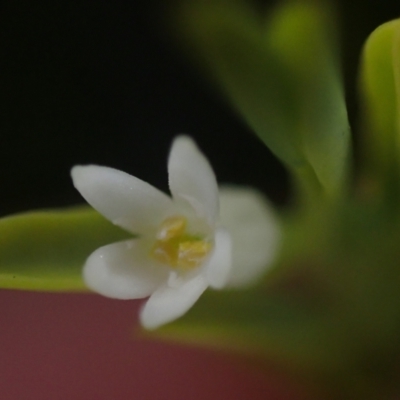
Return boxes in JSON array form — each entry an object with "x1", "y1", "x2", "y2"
[{"x1": 205, "y1": 228, "x2": 232, "y2": 289}]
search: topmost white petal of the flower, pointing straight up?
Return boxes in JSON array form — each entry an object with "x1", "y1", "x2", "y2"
[{"x1": 168, "y1": 136, "x2": 219, "y2": 226}]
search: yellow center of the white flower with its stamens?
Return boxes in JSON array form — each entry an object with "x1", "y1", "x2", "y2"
[{"x1": 151, "y1": 216, "x2": 212, "y2": 270}]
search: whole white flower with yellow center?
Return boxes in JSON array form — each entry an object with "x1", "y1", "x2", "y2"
[{"x1": 72, "y1": 136, "x2": 279, "y2": 329}]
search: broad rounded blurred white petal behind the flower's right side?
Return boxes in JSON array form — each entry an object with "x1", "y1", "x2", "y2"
[{"x1": 220, "y1": 186, "x2": 281, "y2": 287}]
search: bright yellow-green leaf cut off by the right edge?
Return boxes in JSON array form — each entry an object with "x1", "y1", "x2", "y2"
[{"x1": 360, "y1": 20, "x2": 400, "y2": 192}]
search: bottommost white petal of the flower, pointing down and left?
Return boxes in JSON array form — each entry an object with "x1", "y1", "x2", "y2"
[{"x1": 140, "y1": 274, "x2": 208, "y2": 329}]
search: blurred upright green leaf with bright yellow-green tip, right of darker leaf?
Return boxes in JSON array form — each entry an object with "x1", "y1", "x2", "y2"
[{"x1": 267, "y1": 1, "x2": 350, "y2": 195}]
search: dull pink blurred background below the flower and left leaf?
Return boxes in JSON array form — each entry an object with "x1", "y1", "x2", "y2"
[{"x1": 0, "y1": 291, "x2": 304, "y2": 400}]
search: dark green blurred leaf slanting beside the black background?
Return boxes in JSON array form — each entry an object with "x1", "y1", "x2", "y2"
[{"x1": 174, "y1": 0, "x2": 307, "y2": 172}]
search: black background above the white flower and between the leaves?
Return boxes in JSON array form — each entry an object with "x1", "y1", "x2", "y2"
[{"x1": 0, "y1": 0, "x2": 400, "y2": 215}]
